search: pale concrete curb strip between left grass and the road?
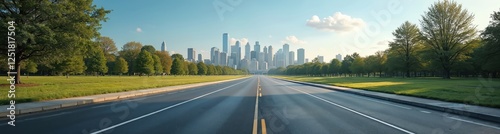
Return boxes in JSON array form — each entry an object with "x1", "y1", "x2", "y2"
[{"x1": 0, "y1": 76, "x2": 249, "y2": 119}]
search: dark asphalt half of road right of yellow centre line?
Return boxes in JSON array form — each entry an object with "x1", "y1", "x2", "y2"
[{"x1": 259, "y1": 76, "x2": 500, "y2": 134}]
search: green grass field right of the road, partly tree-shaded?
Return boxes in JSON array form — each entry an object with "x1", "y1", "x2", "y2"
[{"x1": 274, "y1": 76, "x2": 500, "y2": 108}]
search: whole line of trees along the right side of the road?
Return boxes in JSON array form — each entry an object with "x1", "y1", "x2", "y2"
[{"x1": 268, "y1": 0, "x2": 500, "y2": 79}]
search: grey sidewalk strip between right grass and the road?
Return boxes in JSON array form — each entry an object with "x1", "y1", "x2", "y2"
[{"x1": 276, "y1": 78, "x2": 500, "y2": 123}]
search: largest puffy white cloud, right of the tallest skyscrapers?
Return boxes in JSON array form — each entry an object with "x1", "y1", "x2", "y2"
[{"x1": 307, "y1": 12, "x2": 365, "y2": 32}]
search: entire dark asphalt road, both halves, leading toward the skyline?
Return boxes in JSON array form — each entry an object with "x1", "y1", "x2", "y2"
[{"x1": 0, "y1": 76, "x2": 500, "y2": 134}]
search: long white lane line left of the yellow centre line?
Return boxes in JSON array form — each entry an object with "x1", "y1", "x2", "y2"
[{"x1": 91, "y1": 79, "x2": 249, "y2": 134}]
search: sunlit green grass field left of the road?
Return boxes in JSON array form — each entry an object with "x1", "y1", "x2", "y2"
[{"x1": 0, "y1": 75, "x2": 244, "y2": 105}]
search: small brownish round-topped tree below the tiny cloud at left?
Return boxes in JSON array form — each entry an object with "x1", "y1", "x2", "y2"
[{"x1": 118, "y1": 42, "x2": 142, "y2": 75}]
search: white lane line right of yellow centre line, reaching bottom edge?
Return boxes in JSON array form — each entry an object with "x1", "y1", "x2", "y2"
[{"x1": 275, "y1": 78, "x2": 414, "y2": 134}]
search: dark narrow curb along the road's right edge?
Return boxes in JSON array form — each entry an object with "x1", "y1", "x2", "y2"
[{"x1": 274, "y1": 78, "x2": 500, "y2": 123}]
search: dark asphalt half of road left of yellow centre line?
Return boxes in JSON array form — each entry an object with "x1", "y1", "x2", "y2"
[{"x1": 0, "y1": 77, "x2": 257, "y2": 134}]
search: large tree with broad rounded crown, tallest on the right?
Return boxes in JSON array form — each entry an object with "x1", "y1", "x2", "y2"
[{"x1": 420, "y1": 0, "x2": 476, "y2": 79}]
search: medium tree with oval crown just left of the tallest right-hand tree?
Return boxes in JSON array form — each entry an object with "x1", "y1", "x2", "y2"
[{"x1": 389, "y1": 21, "x2": 420, "y2": 77}]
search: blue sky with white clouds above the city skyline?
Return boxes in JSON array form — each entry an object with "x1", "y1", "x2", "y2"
[{"x1": 94, "y1": 0, "x2": 500, "y2": 61}]
